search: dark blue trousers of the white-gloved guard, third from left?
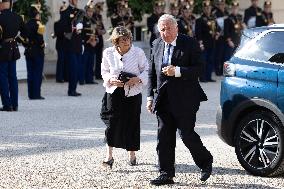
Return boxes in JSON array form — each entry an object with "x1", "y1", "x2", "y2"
[{"x1": 68, "y1": 52, "x2": 82, "y2": 94}]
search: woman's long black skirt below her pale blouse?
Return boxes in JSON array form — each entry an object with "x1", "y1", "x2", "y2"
[{"x1": 101, "y1": 88, "x2": 142, "y2": 151}]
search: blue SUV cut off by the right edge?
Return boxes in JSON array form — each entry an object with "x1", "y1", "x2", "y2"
[{"x1": 216, "y1": 25, "x2": 284, "y2": 176}]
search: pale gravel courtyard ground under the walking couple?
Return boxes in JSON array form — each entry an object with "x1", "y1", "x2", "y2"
[{"x1": 0, "y1": 80, "x2": 284, "y2": 189}]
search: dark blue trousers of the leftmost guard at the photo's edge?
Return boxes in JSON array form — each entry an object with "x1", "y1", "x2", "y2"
[{"x1": 0, "y1": 61, "x2": 18, "y2": 107}]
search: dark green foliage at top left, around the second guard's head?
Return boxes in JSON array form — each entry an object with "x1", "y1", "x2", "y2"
[{"x1": 13, "y1": 0, "x2": 51, "y2": 24}]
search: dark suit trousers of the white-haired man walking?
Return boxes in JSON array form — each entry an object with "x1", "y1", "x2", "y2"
[{"x1": 157, "y1": 89, "x2": 213, "y2": 177}]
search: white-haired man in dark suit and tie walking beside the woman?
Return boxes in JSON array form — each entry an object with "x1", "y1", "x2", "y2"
[{"x1": 147, "y1": 14, "x2": 213, "y2": 185}]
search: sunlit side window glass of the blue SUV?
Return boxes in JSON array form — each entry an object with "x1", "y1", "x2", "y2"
[{"x1": 238, "y1": 31, "x2": 284, "y2": 63}]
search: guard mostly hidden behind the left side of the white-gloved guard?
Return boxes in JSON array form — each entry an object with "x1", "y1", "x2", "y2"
[{"x1": 52, "y1": 1, "x2": 68, "y2": 83}]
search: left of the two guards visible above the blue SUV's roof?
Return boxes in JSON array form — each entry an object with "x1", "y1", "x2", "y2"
[{"x1": 244, "y1": 0, "x2": 262, "y2": 28}]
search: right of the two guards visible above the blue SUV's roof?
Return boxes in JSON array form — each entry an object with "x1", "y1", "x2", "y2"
[{"x1": 256, "y1": 0, "x2": 275, "y2": 27}]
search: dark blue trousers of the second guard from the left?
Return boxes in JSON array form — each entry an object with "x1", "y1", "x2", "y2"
[{"x1": 26, "y1": 56, "x2": 44, "y2": 99}]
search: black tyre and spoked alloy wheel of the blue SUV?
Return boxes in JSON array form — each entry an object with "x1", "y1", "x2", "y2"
[{"x1": 235, "y1": 111, "x2": 284, "y2": 176}]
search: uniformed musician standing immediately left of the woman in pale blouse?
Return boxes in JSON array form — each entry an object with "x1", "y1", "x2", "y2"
[{"x1": 93, "y1": 2, "x2": 106, "y2": 79}]
